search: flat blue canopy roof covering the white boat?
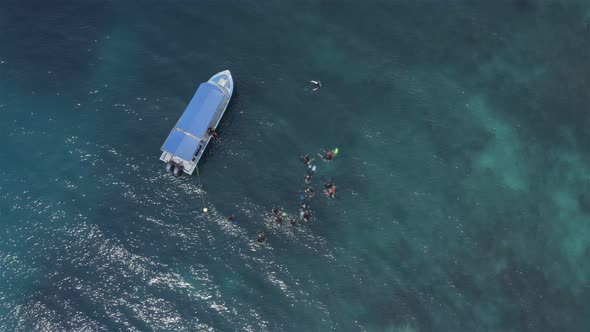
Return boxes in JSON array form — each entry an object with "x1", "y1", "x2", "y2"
[{"x1": 162, "y1": 82, "x2": 225, "y2": 161}]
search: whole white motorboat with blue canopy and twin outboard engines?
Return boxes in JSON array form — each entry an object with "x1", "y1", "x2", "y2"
[{"x1": 160, "y1": 70, "x2": 234, "y2": 176}]
